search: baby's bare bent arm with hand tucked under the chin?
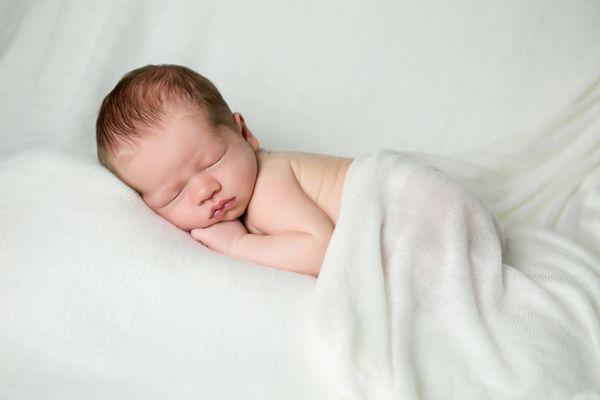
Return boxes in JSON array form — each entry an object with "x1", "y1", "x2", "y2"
[{"x1": 191, "y1": 158, "x2": 334, "y2": 276}]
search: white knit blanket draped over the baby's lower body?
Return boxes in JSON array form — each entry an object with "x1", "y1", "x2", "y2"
[{"x1": 312, "y1": 150, "x2": 600, "y2": 400}]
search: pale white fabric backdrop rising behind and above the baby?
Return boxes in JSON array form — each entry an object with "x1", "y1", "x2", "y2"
[{"x1": 0, "y1": 0, "x2": 600, "y2": 156}]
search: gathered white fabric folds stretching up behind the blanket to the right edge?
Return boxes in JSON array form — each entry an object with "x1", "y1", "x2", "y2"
[{"x1": 414, "y1": 78, "x2": 600, "y2": 257}]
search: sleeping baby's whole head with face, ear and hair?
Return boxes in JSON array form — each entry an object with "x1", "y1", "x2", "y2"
[{"x1": 96, "y1": 65, "x2": 260, "y2": 231}]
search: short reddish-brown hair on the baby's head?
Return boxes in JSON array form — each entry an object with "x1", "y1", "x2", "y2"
[{"x1": 96, "y1": 64, "x2": 236, "y2": 177}]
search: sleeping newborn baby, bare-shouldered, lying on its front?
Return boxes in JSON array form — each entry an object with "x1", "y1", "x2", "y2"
[{"x1": 96, "y1": 65, "x2": 352, "y2": 276}]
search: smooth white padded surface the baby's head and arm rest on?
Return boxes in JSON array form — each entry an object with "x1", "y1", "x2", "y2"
[{"x1": 0, "y1": 150, "x2": 330, "y2": 400}]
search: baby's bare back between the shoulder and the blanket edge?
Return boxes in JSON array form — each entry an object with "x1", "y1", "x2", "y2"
[{"x1": 244, "y1": 150, "x2": 353, "y2": 234}]
